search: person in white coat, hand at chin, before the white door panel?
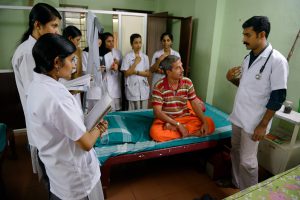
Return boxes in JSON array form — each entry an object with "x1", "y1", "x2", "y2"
[{"x1": 121, "y1": 33, "x2": 150, "y2": 110}]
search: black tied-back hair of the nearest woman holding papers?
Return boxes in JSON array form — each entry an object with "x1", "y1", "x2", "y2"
[{"x1": 32, "y1": 33, "x2": 76, "y2": 74}]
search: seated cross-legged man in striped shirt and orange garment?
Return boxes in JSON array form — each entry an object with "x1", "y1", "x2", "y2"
[{"x1": 150, "y1": 55, "x2": 215, "y2": 142}]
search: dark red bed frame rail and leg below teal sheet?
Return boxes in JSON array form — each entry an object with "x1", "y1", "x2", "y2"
[{"x1": 101, "y1": 138, "x2": 230, "y2": 198}]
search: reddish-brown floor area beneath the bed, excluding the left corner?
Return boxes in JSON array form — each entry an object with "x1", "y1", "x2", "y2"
[{"x1": 104, "y1": 154, "x2": 238, "y2": 200}]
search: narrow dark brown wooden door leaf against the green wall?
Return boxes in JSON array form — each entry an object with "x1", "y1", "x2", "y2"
[{"x1": 179, "y1": 17, "x2": 193, "y2": 77}]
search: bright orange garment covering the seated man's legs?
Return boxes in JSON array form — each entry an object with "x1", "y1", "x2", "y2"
[{"x1": 150, "y1": 115, "x2": 215, "y2": 142}]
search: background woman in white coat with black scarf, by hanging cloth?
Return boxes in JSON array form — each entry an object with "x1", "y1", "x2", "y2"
[{"x1": 99, "y1": 32, "x2": 122, "y2": 111}]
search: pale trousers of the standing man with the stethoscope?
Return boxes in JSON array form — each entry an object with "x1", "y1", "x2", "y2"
[{"x1": 230, "y1": 124, "x2": 259, "y2": 190}]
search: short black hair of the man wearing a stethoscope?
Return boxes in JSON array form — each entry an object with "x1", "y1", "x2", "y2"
[{"x1": 243, "y1": 16, "x2": 271, "y2": 38}]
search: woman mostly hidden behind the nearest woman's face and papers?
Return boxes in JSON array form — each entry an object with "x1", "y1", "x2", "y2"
[{"x1": 63, "y1": 26, "x2": 82, "y2": 107}]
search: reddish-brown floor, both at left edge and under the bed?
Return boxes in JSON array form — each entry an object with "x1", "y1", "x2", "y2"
[{"x1": 1, "y1": 135, "x2": 238, "y2": 200}]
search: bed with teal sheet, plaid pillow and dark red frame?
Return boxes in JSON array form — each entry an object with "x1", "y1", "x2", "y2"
[{"x1": 94, "y1": 104, "x2": 231, "y2": 198}]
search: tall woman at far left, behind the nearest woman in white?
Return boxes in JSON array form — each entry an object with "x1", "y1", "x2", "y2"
[{"x1": 11, "y1": 3, "x2": 61, "y2": 183}]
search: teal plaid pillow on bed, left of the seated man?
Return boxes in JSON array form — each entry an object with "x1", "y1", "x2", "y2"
[{"x1": 96, "y1": 110, "x2": 154, "y2": 146}]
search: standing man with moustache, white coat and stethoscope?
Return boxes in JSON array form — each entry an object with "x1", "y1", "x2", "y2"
[{"x1": 226, "y1": 16, "x2": 288, "y2": 190}]
